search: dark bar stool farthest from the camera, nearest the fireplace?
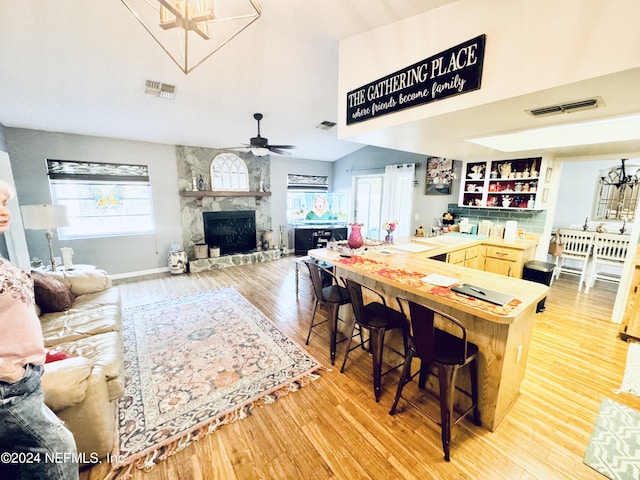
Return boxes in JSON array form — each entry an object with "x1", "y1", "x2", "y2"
[{"x1": 304, "y1": 259, "x2": 351, "y2": 365}]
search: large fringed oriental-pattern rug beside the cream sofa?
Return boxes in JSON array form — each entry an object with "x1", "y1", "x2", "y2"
[{"x1": 112, "y1": 288, "x2": 322, "y2": 478}]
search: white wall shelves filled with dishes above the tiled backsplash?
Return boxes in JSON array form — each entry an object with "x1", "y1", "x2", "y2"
[{"x1": 458, "y1": 157, "x2": 543, "y2": 210}]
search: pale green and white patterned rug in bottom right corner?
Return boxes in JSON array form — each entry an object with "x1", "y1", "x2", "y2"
[{"x1": 584, "y1": 398, "x2": 640, "y2": 480}]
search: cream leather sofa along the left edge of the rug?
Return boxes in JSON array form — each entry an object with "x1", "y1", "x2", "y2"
[{"x1": 36, "y1": 270, "x2": 124, "y2": 459}]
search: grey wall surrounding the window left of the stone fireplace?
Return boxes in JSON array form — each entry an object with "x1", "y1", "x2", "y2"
[{"x1": 5, "y1": 128, "x2": 182, "y2": 274}]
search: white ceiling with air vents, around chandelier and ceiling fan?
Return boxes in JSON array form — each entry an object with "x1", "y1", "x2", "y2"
[{"x1": 0, "y1": 0, "x2": 640, "y2": 161}]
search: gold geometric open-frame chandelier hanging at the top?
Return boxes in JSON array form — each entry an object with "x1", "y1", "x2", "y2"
[{"x1": 122, "y1": 0, "x2": 261, "y2": 74}]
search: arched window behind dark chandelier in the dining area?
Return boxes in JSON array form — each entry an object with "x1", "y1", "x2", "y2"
[{"x1": 593, "y1": 160, "x2": 640, "y2": 220}]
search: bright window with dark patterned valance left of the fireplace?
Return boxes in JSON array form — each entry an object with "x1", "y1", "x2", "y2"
[{"x1": 47, "y1": 160, "x2": 155, "y2": 240}]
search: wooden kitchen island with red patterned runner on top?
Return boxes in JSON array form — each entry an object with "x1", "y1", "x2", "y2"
[{"x1": 309, "y1": 244, "x2": 548, "y2": 431}]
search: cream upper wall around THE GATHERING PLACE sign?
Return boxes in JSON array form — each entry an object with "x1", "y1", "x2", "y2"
[{"x1": 338, "y1": 0, "x2": 640, "y2": 137}]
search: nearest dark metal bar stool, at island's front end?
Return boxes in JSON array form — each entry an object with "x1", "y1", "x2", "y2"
[{"x1": 389, "y1": 296, "x2": 480, "y2": 462}]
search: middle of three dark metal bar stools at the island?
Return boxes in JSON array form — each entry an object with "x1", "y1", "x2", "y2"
[{"x1": 340, "y1": 278, "x2": 409, "y2": 402}]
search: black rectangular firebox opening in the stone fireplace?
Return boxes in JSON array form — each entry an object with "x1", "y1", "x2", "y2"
[{"x1": 202, "y1": 210, "x2": 257, "y2": 255}]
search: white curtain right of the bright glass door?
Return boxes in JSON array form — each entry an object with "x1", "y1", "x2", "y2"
[{"x1": 380, "y1": 163, "x2": 416, "y2": 239}]
